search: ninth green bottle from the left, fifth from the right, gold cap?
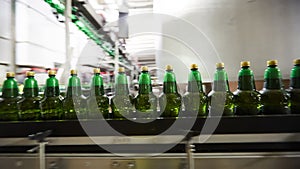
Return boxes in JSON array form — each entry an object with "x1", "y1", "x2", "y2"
[{"x1": 183, "y1": 64, "x2": 208, "y2": 117}]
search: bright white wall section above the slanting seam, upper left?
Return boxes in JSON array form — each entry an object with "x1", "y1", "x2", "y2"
[{"x1": 17, "y1": 1, "x2": 65, "y2": 52}]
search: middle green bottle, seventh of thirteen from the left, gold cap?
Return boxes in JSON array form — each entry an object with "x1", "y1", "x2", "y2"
[{"x1": 134, "y1": 66, "x2": 157, "y2": 118}]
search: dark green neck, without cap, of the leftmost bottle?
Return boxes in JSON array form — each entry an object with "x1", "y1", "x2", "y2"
[{"x1": 2, "y1": 77, "x2": 19, "y2": 98}]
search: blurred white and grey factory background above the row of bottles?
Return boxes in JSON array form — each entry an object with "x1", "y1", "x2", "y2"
[{"x1": 0, "y1": 0, "x2": 300, "y2": 93}]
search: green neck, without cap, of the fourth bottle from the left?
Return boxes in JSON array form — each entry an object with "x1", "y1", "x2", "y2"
[{"x1": 66, "y1": 75, "x2": 81, "y2": 97}]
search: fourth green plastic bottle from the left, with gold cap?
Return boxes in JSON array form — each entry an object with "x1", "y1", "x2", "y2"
[{"x1": 63, "y1": 70, "x2": 88, "y2": 120}]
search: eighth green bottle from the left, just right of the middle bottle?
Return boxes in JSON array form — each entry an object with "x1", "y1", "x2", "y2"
[{"x1": 159, "y1": 65, "x2": 181, "y2": 117}]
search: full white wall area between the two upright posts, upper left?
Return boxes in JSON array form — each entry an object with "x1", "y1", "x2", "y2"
[{"x1": 16, "y1": 0, "x2": 65, "y2": 68}]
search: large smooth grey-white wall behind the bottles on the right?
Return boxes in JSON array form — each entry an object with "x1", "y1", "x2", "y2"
[{"x1": 154, "y1": 0, "x2": 300, "y2": 82}]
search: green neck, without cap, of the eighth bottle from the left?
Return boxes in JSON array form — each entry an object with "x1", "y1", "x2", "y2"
[{"x1": 163, "y1": 71, "x2": 178, "y2": 94}]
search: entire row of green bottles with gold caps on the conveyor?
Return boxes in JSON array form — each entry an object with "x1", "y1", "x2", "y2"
[{"x1": 0, "y1": 59, "x2": 300, "y2": 121}]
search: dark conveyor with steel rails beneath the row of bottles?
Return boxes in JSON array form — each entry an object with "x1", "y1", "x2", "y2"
[{"x1": 0, "y1": 115, "x2": 300, "y2": 169}]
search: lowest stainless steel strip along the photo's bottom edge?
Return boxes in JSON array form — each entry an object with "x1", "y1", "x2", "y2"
[{"x1": 0, "y1": 152, "x2": 300, "y2": 169}]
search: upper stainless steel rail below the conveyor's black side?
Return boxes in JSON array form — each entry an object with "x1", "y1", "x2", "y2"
[{"x1": 0, "y1": 133, "x2": 300, "y2": 147}]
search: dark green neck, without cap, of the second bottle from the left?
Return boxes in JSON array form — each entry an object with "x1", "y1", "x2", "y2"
[{"x1": 23, "y1": 76, "x2": 39, "y2": 98}]
